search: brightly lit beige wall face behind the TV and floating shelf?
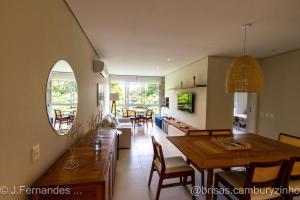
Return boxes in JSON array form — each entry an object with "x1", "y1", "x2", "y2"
[{"x1": 165, "y1": 57, "x2": 208, "y2": 129}]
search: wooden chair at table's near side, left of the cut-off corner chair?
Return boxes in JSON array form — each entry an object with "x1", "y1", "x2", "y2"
[{"x1": 213, "y1": 160, "x2": 287, "y2": 200}]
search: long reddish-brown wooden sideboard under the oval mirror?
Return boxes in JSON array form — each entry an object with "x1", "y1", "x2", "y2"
[{"x1": 32, "y1": 130, "x2": 118, "y2": 200}]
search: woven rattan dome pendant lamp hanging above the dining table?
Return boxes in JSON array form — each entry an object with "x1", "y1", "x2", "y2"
[{"x1": 226, "y1": 24, "x2": 263, "y2": 93}]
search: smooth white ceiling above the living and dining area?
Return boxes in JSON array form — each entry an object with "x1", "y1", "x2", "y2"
[{"x1": 66, "y1": 0, "x2": 300, "y2": 76}]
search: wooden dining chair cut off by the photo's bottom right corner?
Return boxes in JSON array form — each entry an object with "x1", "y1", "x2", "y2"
[{"x1": 285, "y1": 157, "x2": 300, "y2": 200}]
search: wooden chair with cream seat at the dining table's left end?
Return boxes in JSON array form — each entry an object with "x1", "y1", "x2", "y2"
[{"x1": 148, "y1": 136, "x2": 195, "y2": 200}]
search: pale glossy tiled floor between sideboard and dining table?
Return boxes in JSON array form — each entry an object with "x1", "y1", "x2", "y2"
[{"x1": 113, "y1": 126, "x2": 203, "y2": 200}]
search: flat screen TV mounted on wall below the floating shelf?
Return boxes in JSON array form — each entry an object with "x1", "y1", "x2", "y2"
[{"x1": 177, "y1": 92, "x2": 194, "y2": 113}]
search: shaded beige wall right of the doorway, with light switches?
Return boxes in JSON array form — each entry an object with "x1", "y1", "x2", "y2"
[{"x1": 258, "y1": 50, "x2": 300, "y2": 139}]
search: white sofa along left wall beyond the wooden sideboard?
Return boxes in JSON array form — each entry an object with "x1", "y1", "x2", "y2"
[{"x1": 99, "y1": 114, "x2": 132, "y2": 149}]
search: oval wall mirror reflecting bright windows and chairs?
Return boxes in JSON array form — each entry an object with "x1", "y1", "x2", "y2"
[{"x1": 46, "y1": 60, "x2": 78, "y2": 135}]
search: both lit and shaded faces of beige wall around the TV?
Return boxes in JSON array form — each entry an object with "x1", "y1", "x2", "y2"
[{"x1": 165, "y1": 56, "x2": 234, "y2": 129}]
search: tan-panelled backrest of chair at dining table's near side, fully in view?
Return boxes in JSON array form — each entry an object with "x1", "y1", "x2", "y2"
[{"x1": 245, "y1": 160, "x2": 287, "y2": 188}]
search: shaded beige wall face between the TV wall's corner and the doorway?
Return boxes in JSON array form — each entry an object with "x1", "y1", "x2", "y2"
[{"x1": 206, "y1": 56, "x2": 234, "y2": 129}]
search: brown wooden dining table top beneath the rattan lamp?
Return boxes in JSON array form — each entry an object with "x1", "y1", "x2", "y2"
[{"x1": 167, "y1": 133, "x2": 300, "y2": 169}]
